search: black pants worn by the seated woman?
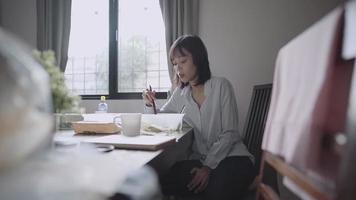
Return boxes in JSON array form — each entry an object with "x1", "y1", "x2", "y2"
[{"x1": 160, "y1": 156, "x2": 256, "y2": 200}]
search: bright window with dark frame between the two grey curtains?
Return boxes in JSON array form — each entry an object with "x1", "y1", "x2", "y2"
[{"x1": 65, "y1": 0, "x2": 171, "y2": 99}]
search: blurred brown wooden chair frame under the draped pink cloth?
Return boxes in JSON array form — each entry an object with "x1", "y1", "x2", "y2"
[{"x1": 256, "y1": 61, "x2": 356, "y2": 200}]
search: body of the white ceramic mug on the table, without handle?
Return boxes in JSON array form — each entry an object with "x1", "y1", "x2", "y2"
[{"x1": 121, "y1": 113, "x2": 141, "y2": 137}]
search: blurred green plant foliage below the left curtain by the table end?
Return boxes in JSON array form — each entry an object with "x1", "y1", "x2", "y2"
[{"x1": 34, "y1": 50, "x2": 80, "y2": 113}]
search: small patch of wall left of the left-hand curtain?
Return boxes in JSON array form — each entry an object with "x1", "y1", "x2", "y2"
[{"x1": 0, "y1": 0, "x2": 37, "y2": 48}]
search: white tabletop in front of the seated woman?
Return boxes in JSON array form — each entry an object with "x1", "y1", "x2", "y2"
[{"x1": 50, "y1": 128, "x2": 192, "y2": 196}]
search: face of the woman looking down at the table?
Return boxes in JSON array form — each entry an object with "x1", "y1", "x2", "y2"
[{"x1": 172, "y1": 49, "x2": 198, "y2": 83}]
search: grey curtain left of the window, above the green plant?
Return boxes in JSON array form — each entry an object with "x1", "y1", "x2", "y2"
[{"x1": 36, "y1": 0, "x2": 72, "y2": 72}]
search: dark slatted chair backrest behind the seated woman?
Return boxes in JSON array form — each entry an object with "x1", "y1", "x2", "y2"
[{"x1": 243, "y1": 84, "x2": 272, "y2": 169}]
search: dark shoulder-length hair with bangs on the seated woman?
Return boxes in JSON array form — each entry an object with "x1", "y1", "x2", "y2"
[{"x1": 169, "y1": 35, "x2": 211, "y2": 88}]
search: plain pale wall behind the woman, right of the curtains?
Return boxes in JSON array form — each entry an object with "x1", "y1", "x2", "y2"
[{"x1": 199, "y1": 0, "x2": 342, "y2": 129}]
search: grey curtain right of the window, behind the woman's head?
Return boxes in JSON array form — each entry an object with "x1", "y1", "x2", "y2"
[{"x1": 159, "y1": 0, "x2": 199, "y2": 89}]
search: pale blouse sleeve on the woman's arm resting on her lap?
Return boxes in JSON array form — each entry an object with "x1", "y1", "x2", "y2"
[{"x1": 203, "y1": 79, "x2": 241, "y2": 169}]
